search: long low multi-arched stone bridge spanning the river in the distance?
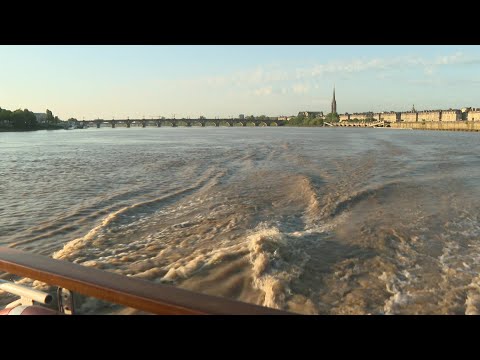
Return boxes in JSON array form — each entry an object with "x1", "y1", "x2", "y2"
[{"x1": 78, "y1": 119, "x2": 287, "y2": 128}]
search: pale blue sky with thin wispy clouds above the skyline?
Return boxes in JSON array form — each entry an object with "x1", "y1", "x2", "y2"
[{"x1": 0, "y1": 45, "x2": 480, "y2": 120}]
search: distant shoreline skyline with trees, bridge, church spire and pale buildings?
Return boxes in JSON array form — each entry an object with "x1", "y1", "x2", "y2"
[{"x1": 0, "y1": 88, "x2": 480, "y2": 130}]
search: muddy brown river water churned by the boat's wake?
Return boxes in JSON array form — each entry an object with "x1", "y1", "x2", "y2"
[{"x1": 0, "y1": 127, "x2": 480, "y2": 314}]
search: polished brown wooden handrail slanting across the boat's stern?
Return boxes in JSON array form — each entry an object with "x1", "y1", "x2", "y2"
[{"x1": 0, "y1": 247, "x2": 292, "y2": 315}]
